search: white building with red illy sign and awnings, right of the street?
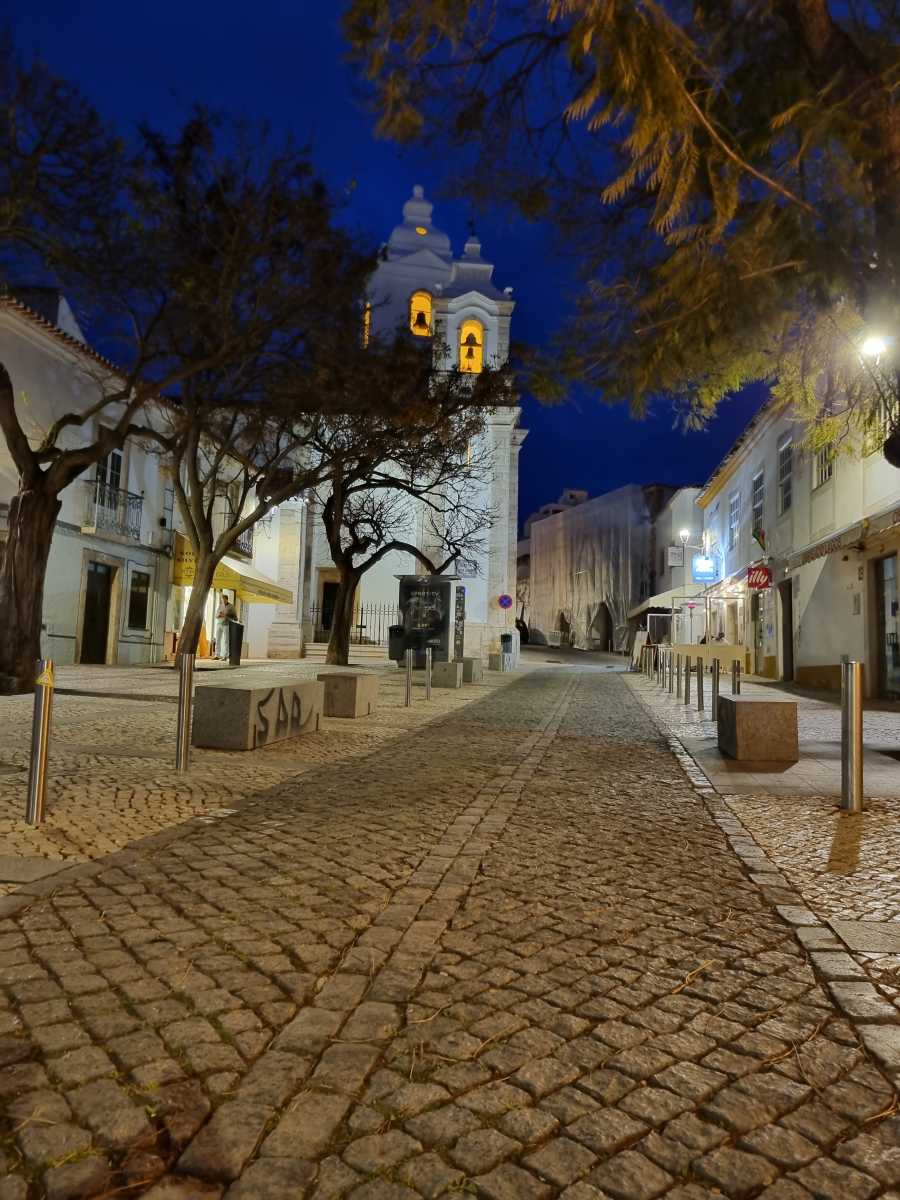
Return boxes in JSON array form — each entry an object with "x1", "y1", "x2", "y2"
[{"x1": 700, "y1": 404, "x2": 900, "y2": 700}]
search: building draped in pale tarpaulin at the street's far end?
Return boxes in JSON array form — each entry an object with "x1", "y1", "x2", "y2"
[{"x1": 528, "y1": 484, "x2": 674, "y2": 650}]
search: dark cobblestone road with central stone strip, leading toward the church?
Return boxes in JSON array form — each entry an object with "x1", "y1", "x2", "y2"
[{"x1": 0, "y1": 667, "x2": 900, "y2": 1200}]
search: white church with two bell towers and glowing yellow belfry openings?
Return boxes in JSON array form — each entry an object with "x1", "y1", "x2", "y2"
[{"x1": 304, "y1": 186, "x2": 526, "y2": 656}]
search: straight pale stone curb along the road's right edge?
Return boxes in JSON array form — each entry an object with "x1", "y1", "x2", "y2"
[{"x1": 625, "y1": 676, "x2": 900, "y2": 1088}]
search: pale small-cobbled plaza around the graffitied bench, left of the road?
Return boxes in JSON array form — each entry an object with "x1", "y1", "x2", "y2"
[{"x1": 0, "y1": 662, "x2": 505, "y2": 895}]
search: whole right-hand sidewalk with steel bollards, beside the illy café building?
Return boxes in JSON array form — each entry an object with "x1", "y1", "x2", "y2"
[{"x1": 628, "y1": 674, "x2": 900, "y2": 1001}]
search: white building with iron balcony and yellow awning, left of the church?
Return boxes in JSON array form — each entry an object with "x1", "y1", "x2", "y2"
[{"x1": 0, "y1": 288, "x2": 305, "y2": 666}]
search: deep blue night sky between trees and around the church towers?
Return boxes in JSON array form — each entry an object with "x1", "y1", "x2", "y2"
[{"x1": 12, "y1": 0, "x2": 761, "y2": 518}]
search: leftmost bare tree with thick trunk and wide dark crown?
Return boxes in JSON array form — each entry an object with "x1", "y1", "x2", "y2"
[{"x1": 0, "y1": 74, "x2": 371, "y2": 692}]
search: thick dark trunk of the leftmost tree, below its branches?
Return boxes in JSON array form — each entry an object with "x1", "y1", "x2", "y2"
[{"x1": 0, "y1": 487, "x2": 61, "y2": 696}]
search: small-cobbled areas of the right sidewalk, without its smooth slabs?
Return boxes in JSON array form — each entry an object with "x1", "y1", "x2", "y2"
[{"x1": 628, "y1": 676, "x2": 900, "y2": 1004}]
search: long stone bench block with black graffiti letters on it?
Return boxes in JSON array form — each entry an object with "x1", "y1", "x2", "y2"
[{"x1": 192, "y1": 679, "x2": 325, "y2": 750}]
